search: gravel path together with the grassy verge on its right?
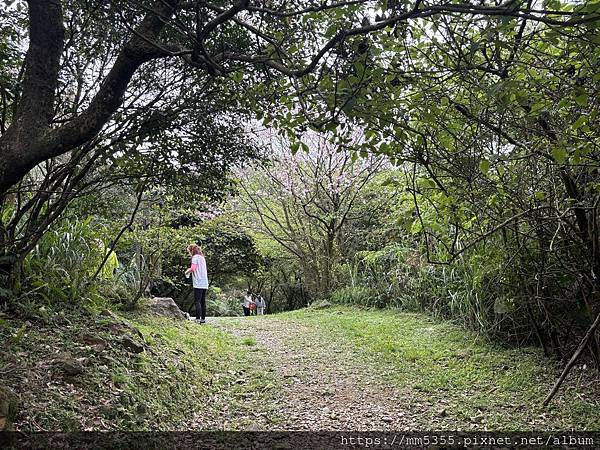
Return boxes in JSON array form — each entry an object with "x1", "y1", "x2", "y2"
[{"x1": 187, "y1": 307, "x2": 600, "y2": 431}]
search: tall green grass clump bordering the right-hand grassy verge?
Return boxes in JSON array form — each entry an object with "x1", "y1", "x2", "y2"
[{"x1": 331, "y1": 243, "x2": 512, "y2": 342}]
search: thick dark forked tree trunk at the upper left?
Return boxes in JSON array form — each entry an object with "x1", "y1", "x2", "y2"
[{"x1": 0, "y1": 0, "x2": 179, "y2": 197}]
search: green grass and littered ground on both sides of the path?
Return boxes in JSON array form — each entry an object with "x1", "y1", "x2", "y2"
[{"x1": 0, "y1": 307, "x2": 600, "y2": 431}]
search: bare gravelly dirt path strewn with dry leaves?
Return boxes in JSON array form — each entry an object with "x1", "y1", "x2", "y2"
[{"x1": 209, "y1": 317, "x2": 418, "y2": 431}]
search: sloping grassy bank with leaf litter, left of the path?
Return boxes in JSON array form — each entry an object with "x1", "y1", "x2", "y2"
[{"x1": 0, "y1": 312, "x2": 276, "y2": 431}]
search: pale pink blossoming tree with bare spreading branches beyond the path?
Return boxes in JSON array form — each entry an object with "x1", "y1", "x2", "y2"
[{"x1": 240, "y1": 133, "x2": 385, "y2": 298}]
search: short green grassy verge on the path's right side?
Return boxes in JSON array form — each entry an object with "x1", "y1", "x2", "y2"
[{"x1": 279, "y1": 307, "x2": 600, "y2": 430}]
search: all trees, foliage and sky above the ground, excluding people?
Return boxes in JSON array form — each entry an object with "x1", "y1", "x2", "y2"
[{"x1": 0, "y1": 0, "x2": 600, "y2": 390}]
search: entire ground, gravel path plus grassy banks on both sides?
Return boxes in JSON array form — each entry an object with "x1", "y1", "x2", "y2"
[{"x1": 0, "y1": 306, "x2": 600, "y2": 431}]
